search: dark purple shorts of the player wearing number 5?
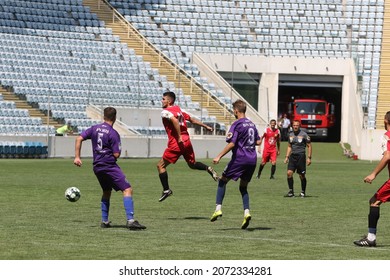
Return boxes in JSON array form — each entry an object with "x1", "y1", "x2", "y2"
[{"x1": 94, "y1": 165, "x2": 131, "y2": 191}]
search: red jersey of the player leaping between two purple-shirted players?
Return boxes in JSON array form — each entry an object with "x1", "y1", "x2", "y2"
[{"x1": 161, "y1": 105, "x2": 191, "y2": 147}]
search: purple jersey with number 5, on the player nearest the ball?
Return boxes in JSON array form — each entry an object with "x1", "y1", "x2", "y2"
[{"x1": 81, "y1": 122, "x2": 121, "y2": 172}]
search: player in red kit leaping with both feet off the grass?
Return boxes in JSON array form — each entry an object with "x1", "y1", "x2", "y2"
[{"x1": 157, "y1": 91, "x2": 218, "y2": 202}]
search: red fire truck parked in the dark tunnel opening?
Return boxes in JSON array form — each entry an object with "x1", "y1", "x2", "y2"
[{"x1": 288, "y1": 98, "x2": 335, "y2": 139}]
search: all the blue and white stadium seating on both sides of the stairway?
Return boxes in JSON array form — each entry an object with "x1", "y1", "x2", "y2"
[{"x1": 0, "y1": 0, "x2": 385, "y2": 134}]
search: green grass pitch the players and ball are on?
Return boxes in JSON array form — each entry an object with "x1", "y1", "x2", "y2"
[{"x1": 0, "y1": 143, "x2": 390, "y2": 260}]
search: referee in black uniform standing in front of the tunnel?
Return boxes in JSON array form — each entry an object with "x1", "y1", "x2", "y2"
[{"x1": 284, "y1": 120, "x2": 312, "y2": 197}]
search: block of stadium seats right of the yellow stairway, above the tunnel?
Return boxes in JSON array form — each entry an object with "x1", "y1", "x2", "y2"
[{"x1": 110, "y1": 0, "x2": 384, "y2": 129}]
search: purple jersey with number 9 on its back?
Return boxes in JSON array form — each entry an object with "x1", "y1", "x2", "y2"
[{"x1": 226, "y1": 118, "x2": 260, "y2": 165}]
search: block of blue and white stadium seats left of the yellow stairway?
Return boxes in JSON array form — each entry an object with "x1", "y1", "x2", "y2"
[{"x1": 0, "y1": 0, "x2": 210, "y2": 135}]
